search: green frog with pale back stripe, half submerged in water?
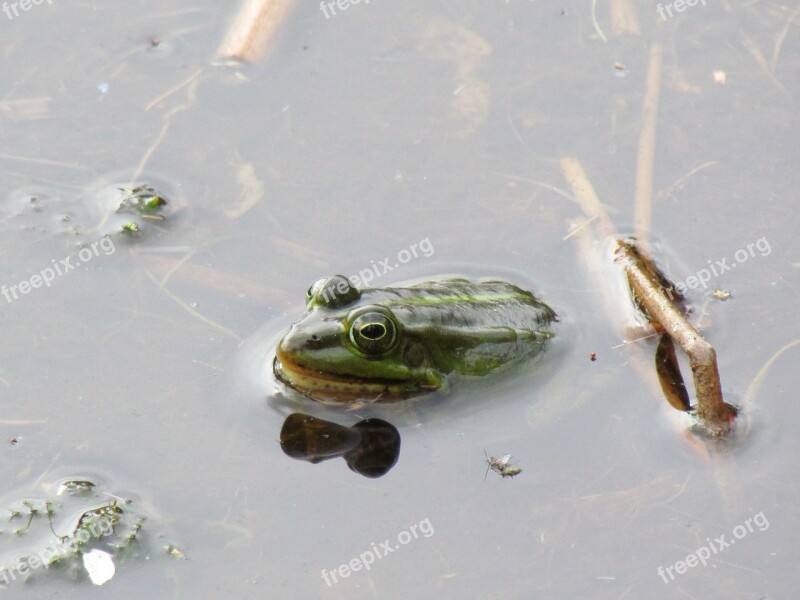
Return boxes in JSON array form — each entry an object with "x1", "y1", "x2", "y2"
[{"x1": 273, "y1": 275, "x2": 558, "y2": 403}]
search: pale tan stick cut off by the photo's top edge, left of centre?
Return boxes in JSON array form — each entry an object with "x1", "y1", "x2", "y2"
[{"x1": 217, "y1": 0, "x2": 295, "y2": 61}]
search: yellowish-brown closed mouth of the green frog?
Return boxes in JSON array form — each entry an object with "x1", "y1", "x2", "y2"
[{"x1": 272, "y1": 349, "x2": 421, "y2": 404}]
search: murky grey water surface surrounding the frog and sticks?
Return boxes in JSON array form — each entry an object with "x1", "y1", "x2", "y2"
[{"x1": 0, "y1": 0, "x2": 800, "y2": 598}]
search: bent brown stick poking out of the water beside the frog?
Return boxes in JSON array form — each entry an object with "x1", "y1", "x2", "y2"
[{"x1": 617, "y1": 240, "x2": 736, "y2": 436}]
